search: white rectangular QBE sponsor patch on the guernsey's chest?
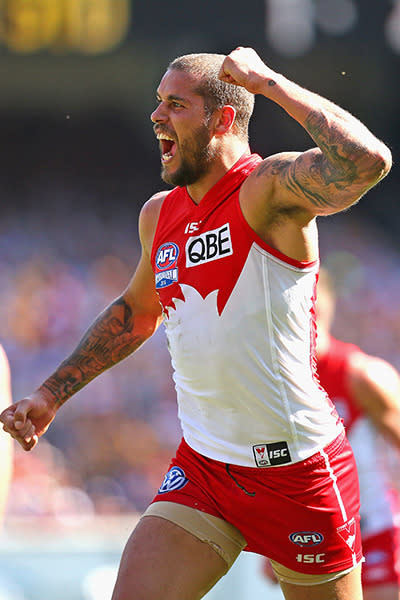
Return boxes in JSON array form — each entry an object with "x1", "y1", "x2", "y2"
[{"x1": 186, "y1": 223, "x2": 233, "y2": 267}]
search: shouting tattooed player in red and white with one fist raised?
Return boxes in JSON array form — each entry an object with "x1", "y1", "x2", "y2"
[{"x1": 0, "y1": 48, "x2": 391, "y2": 600}]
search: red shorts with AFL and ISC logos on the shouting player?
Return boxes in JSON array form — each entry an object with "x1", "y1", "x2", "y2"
[{"x1": 153, "y1": 434, "x2": 362, "y2": 574}]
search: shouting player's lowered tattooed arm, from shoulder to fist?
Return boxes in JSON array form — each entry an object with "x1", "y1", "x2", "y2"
[{"x1": 0, "y1": 195, "x2": 162, "y2": 450}]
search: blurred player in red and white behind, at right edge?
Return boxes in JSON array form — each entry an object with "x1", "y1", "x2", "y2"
[{"x1": 265, "y1": 269, "x2": 400, "y2": 600}]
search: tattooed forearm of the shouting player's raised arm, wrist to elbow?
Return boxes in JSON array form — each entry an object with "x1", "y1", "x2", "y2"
[{"x1": 259, "y1": 72, "x2": 391, "y2": 187}]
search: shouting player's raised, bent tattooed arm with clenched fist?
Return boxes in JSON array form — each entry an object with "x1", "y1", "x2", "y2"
[{"x1": 220, "y1": 48, "x2": 391, "y2": 215}]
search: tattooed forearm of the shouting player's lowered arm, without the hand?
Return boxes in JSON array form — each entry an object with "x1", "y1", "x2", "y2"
[{"x1": 42, "y1": 298, "x2": 147, "y2": 406}]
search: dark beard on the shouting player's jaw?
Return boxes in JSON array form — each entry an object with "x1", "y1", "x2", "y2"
[{"x1": 161, "y1": 125, "x2": 216, "y2": 187}]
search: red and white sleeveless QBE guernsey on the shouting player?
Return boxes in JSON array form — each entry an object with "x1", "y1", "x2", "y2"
[{"x1": 151, "y1": 154, "x2": 343, "y2": 467}]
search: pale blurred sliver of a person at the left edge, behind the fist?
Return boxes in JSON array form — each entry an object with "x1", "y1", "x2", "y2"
[{"x1": 0, "y1": 344, "x2": 13, "y2": 525}]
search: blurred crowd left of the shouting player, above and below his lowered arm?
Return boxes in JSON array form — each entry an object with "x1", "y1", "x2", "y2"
[{"x1": 0, "y1": 209, "x2": 180, "y2": 519}]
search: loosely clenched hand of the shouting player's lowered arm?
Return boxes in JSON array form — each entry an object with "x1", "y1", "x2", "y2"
[{"x1": 0, "y1": 392, "x2": 56, "y2": 450}]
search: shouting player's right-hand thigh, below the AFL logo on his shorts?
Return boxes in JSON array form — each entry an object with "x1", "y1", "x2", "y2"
[{"x1": 280, "y1": 565, "x2": 363, "y2": 600}]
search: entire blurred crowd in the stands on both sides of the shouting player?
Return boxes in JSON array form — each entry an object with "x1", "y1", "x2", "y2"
[{"x1": 0, "y1": 202, "x2": 400, "y2": 522}]
